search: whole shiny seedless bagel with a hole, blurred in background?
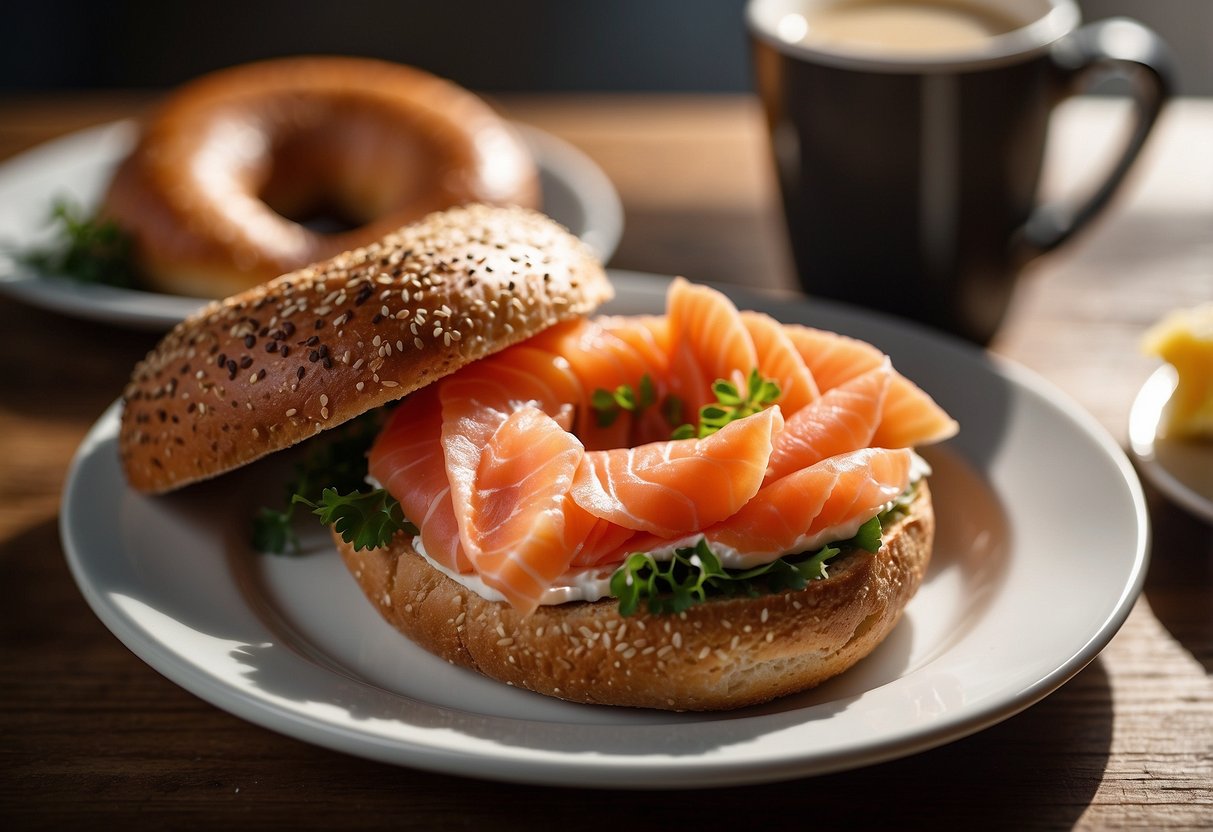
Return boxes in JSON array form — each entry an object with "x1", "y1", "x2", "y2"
[{"x1": 104, "y1": 57, "x2": 539, "y2": 297}]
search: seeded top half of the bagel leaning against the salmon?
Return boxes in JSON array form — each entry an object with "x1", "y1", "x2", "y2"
[{"x1": 119, "y1": 205, "x2": 613, "y2": 492}]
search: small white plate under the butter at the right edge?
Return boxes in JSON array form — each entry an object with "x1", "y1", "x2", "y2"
[{"x1": 1129, "y1": 364, "x2": 1213, "y2": 523}]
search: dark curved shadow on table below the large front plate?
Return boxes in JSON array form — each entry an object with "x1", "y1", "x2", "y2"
[{"x1": 337, "y1": 659, "x2": 1112, "y2": 832}]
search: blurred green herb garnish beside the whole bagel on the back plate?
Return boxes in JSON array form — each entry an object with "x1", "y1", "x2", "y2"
[{"x1": 17, "y1": 199, "x2": 139, "y2": 289}]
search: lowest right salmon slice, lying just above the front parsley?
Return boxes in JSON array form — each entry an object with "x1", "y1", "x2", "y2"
[{"x1": 704, "y1": 448, "x2": 910, "y2": 566}]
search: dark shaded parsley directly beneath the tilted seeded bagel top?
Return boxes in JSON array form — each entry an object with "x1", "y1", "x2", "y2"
[{"x1": 252, "y1": 414, "x2": 380, "y2": 554}]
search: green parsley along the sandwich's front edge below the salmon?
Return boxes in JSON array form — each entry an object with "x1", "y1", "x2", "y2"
[{"x1": 610, "y1": 517, "x2": 882, "y2": 616}]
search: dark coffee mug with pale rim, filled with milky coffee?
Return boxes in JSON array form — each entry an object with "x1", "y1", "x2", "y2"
[{"x1": 746, "y1": 0, "x2": 1173, "y2": 343}]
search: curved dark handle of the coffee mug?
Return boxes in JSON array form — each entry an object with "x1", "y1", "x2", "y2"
[{"x1": 1021, "y1": 18, "x2": 1175, "y2": 260}]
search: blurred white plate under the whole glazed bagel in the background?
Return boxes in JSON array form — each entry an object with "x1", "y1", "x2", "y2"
[{"x1": 0, "y1": 121, "x2": 623, "y2": 331}]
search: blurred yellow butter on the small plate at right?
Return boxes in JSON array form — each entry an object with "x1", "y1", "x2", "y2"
[{"x1": 1143, "y1": 303, "x2": 1213, "y2": 439}]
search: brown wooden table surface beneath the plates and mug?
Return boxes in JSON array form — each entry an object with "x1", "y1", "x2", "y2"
[{"x1": 0, "y1": 95, "x2": 1213, "y2": 830}]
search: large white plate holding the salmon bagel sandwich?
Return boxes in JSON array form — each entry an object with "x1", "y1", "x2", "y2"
[{"x1": 62, "y1": 273, "x2": 1146, "y2": 787}]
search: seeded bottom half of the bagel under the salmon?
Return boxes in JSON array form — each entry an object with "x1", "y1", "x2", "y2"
[{"x1": 334, "y1": 481, "x2": 935, "y2": 711}]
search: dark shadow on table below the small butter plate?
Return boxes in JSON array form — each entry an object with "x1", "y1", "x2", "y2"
[{"x1": 1145, "y1": 484, "x2": 1213, "y2": 674}]
